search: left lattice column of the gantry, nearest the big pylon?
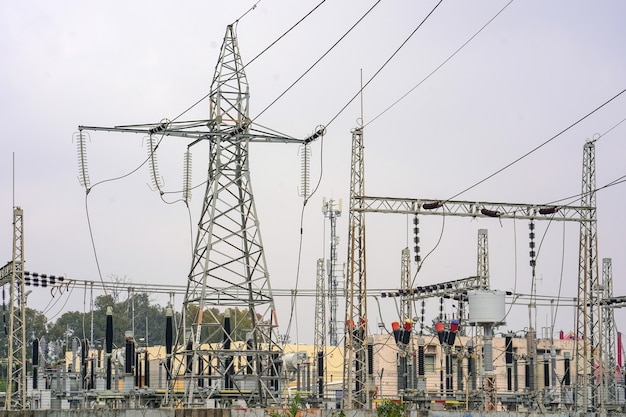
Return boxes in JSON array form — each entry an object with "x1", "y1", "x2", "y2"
[{"x1": 342, "y1": 128, "x2": 369, "y2": 409}]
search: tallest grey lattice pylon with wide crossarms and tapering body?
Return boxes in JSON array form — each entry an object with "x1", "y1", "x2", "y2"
[{"x1": 79, "y1": 25, "x2": 324, "y2": 407}]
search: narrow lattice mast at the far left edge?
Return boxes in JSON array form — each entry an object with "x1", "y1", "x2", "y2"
[{"x1": 0, "y1": 207, "x2": 27, "y2": 410}]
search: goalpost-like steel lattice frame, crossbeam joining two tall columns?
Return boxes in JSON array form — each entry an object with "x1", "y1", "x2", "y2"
[{"x1": 343, "y1": 120, "x2": 601, "y2": 408}]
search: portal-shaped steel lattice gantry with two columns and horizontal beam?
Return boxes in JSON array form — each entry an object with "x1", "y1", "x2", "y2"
[{"x1": 343, "y1": 132, "x2": 606, "y2": 410}]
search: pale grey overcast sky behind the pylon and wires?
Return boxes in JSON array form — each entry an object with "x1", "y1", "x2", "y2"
[{"x1": 0, "y1": 0, "x2": 626, "y2": 343}]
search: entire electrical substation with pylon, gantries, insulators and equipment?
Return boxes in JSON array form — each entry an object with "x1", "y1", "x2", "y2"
[{"x1": 0, "y1": 14, "x2": 626, "y2": 417}]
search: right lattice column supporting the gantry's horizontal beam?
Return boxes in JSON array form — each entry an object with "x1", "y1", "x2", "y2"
[{"x1": 576, "y1": 139, "x2": 604, "y2": 410}]
